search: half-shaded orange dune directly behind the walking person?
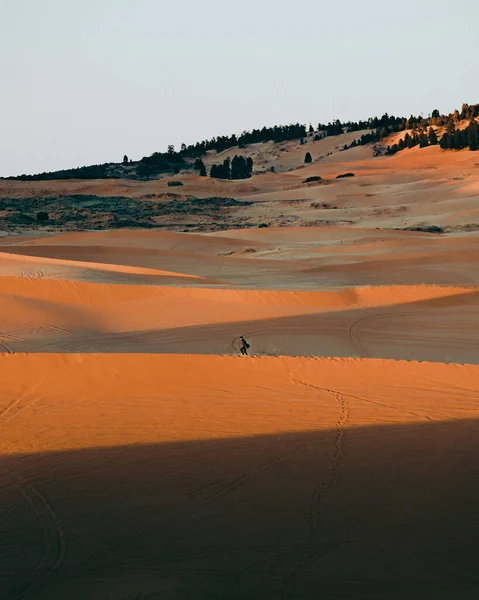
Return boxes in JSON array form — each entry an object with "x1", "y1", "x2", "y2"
[{"x1": 0, "y1": 265, "x2": 479, "y2": 363}]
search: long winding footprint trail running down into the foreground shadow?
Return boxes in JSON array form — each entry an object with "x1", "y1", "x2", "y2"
[{"x1": 282, "y1": 374, "x2": 350, "y2": 600}]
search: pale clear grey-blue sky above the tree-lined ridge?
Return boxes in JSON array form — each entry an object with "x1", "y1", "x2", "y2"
[{"x1": 0, "y1": 0, "x2": 479, "y2": 176}]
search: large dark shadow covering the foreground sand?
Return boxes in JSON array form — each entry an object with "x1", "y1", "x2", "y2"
[{"x1": 0, "y1": 420, "x2": 479, "y2": 600}]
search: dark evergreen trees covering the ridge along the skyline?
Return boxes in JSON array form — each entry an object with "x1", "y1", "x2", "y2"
[{"x1": 3, "y1": 104, "x2": 479, "y2": 181}]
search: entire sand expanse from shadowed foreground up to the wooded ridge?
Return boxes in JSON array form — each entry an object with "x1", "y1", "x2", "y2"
[{"x1": 0, "y1": 142, "x2": 479, "y2": 600}]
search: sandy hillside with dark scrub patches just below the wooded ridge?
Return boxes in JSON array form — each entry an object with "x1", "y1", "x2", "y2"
[{"x1": 0, "y1": 123, "x2": 479, "y2": 233}]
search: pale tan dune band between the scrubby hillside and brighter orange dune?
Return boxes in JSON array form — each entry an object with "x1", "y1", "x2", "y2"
[{"x1": 0, "y1": 227, "x2": 479, "y2": 290}]
